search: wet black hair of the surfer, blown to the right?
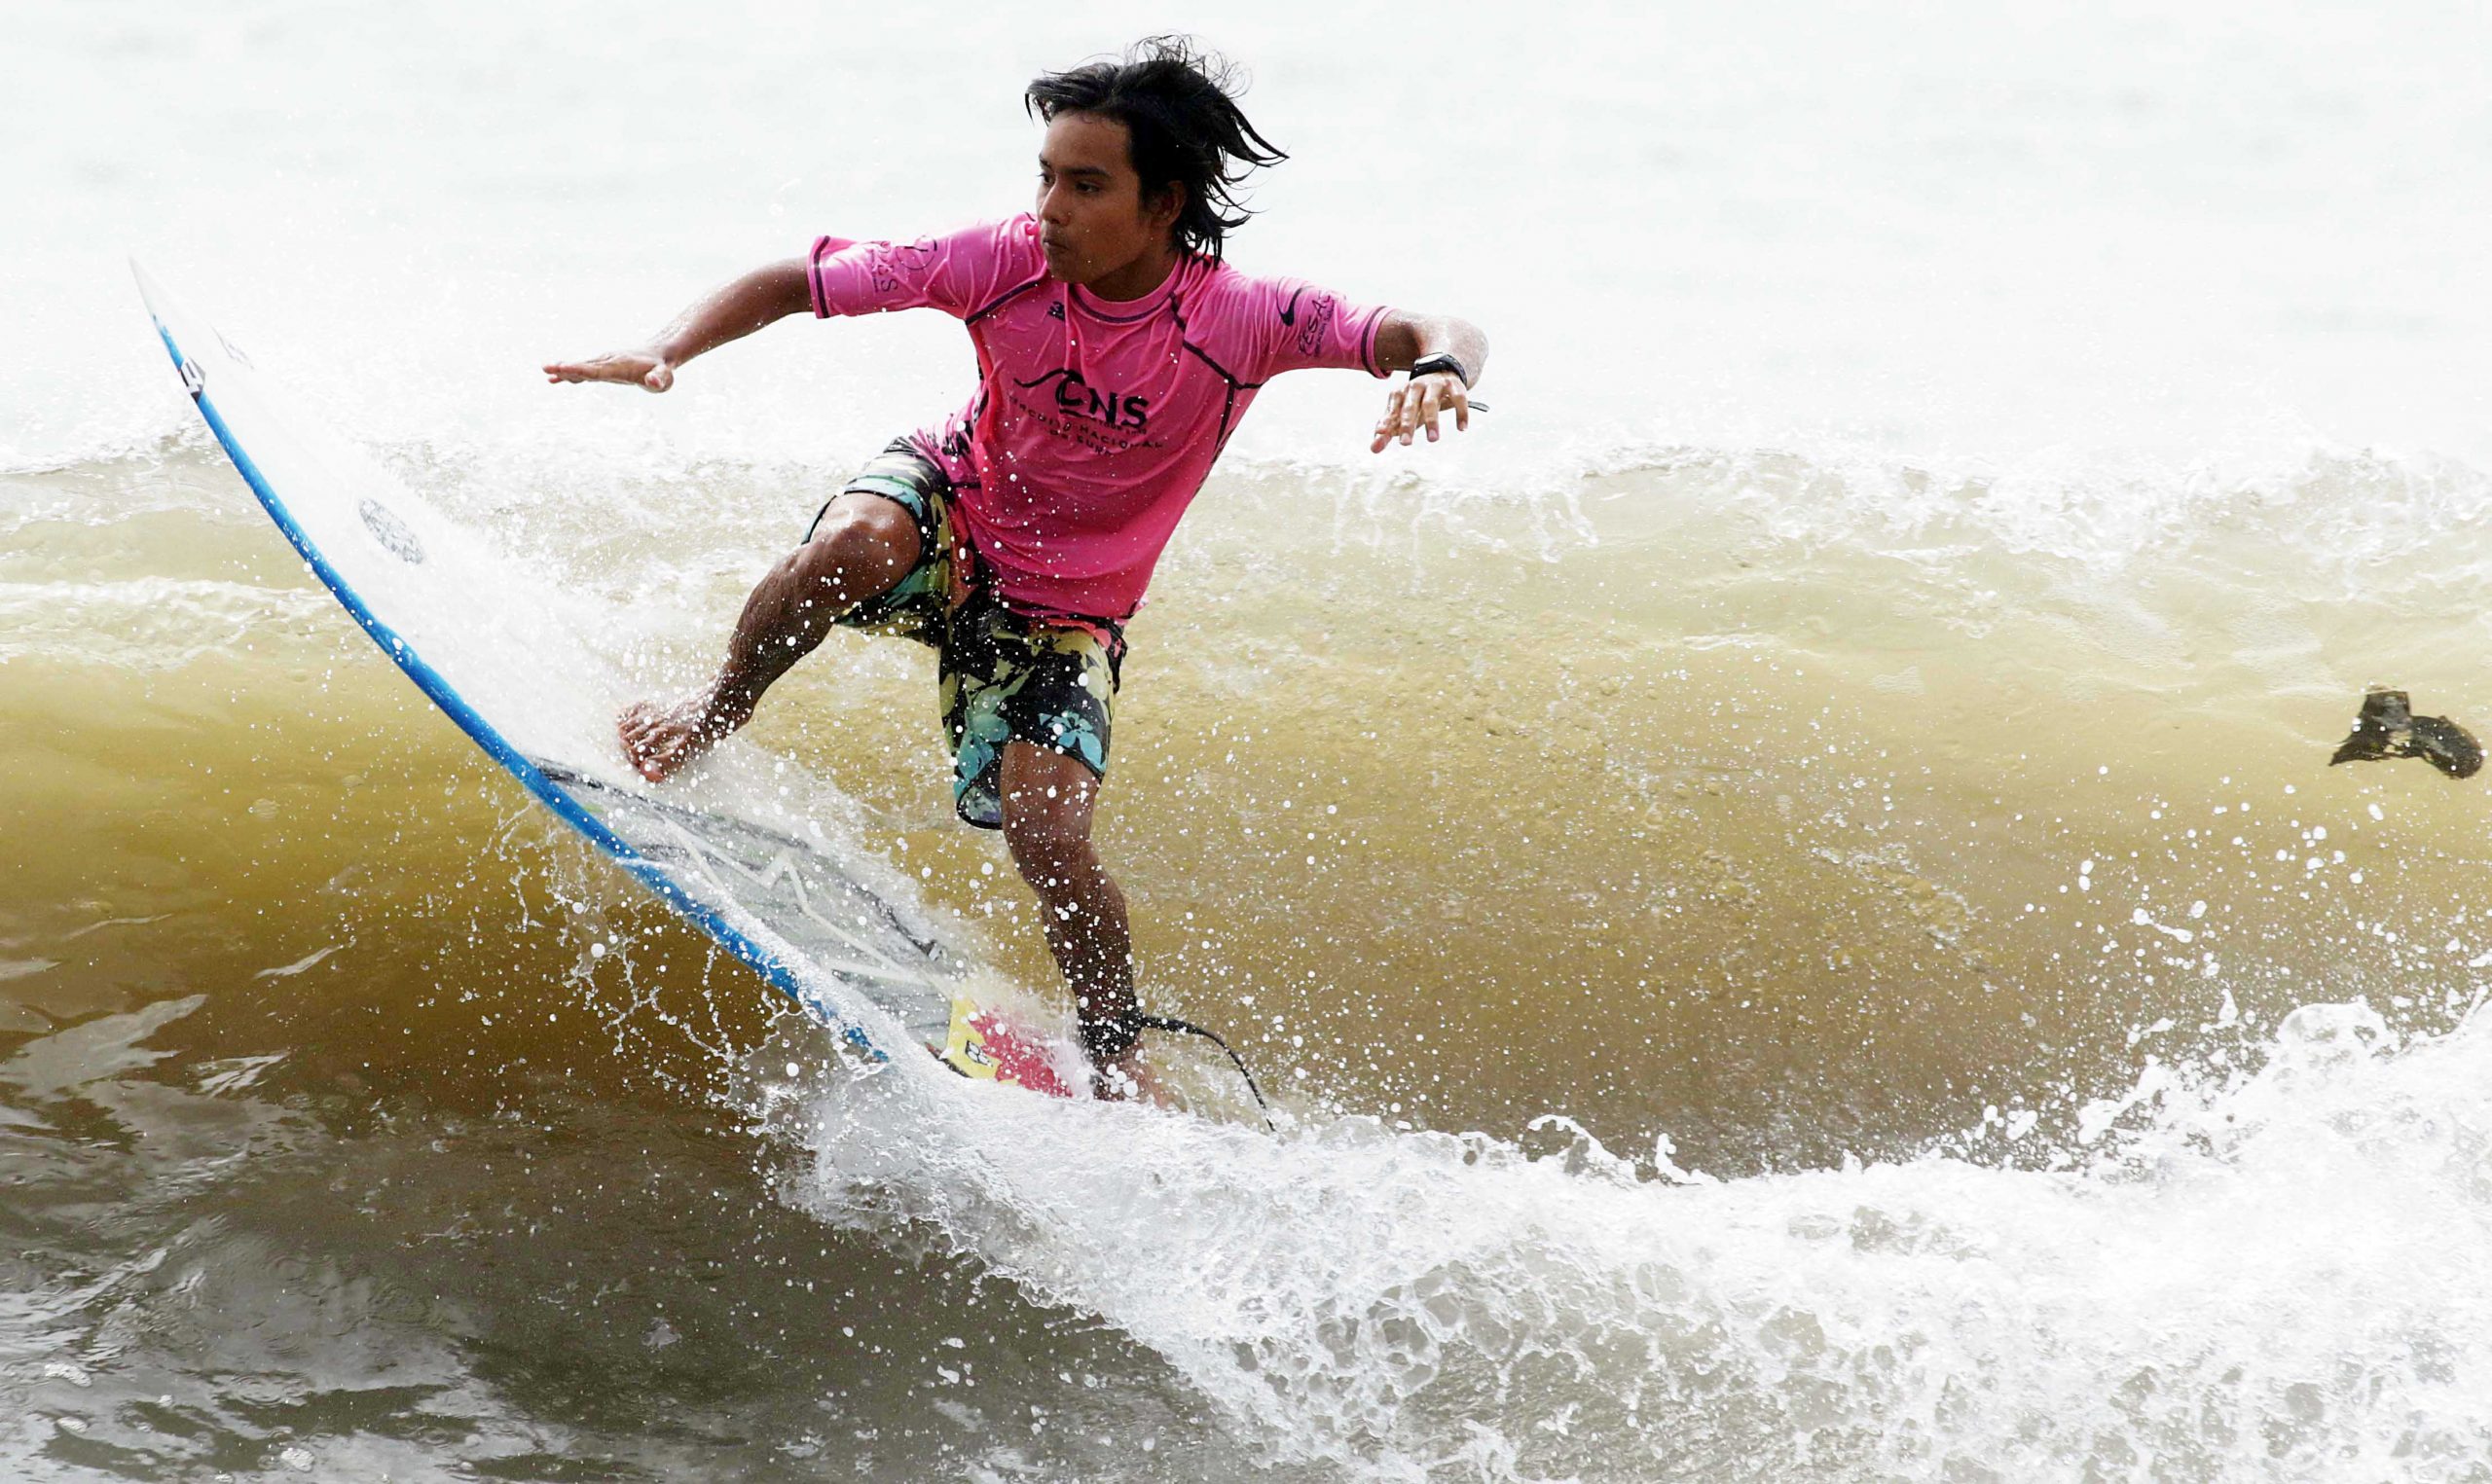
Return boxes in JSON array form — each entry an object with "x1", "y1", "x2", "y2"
[{"x1": 1022, "y1": 35, "x2": 1289, "y2": 259}]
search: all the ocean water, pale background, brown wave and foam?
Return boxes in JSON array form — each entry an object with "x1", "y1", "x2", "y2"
[{"x1": 0, "y1": 5, "x2": 2492, "y2": 1481}]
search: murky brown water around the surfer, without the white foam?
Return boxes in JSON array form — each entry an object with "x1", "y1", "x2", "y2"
[{"x1": 0, "y1": 449, "x2": 2492, "y2": 1479}]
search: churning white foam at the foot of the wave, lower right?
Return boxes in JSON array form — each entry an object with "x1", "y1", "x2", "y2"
[{"x1": 788, "y1": 1003, "x2": 2492, "y2": 1479}]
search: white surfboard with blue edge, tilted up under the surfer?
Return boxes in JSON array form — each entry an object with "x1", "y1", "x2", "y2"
[{"x1": 129, "y1": 262, "x2": 1086, "y2": 1098}]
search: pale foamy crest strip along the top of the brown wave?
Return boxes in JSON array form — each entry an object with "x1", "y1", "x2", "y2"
[{"x1": 23, "y1": 420, "x2": 2492, "y2": 596}]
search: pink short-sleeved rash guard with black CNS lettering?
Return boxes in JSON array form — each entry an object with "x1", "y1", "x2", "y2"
[{"x1": 807, "y1": 214, "x2": 1385, "y2": 623}]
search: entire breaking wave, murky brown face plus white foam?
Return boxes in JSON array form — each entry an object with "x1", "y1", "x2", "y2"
[{"x1": 15, "y1": 422, "x2": 2492, "y2": 1479}]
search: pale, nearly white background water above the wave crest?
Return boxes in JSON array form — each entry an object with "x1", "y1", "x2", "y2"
[{"x1": 0, "y1": 3, "x2": 2492, "y2": 481}]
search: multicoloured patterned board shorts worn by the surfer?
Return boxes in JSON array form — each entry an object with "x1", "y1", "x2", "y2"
[{"x1": 805, "y1": 438, "x2": 1124, "y2": 829}]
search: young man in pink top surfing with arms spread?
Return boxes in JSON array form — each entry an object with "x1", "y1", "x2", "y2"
[{"x1": 546, "y1": 37, "x2": 1487, "y2": 1093}]
